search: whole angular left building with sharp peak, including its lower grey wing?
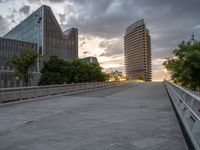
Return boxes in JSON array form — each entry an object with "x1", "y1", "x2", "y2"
[{"x1": 0, "y1": 5, "x2": 78, "y2": 88}]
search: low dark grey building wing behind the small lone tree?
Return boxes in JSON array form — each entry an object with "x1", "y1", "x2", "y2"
[{"x1": 0, "y1": 38, "x2": 37, "y2": 88}]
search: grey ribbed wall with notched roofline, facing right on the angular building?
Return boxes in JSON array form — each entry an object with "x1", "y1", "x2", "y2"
[{"x1": 43, "y1": 6, "x2": 78, "y2": 60}]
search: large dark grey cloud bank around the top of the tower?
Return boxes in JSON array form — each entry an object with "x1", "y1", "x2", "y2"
[{"x1": 60, "y1": 0, "x2": 200, "y2": 58}]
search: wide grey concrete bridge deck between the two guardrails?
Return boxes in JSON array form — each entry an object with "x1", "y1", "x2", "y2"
[{"x1": 0, "y1": 83, "x2": 188, "y2": 150}]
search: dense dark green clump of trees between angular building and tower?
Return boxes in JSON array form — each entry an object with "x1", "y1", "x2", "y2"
[{"x1": 40, "y1": 56, "x2": 107, "y2": 85}]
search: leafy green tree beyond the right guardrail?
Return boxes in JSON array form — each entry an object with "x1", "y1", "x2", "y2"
[{"x1": 163, "y1": 41, "x2": 200, "y2": 90}]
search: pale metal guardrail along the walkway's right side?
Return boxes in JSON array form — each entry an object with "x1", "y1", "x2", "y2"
[{"x1": 164, "y1": 81, "x2": 200, "y2": 150}]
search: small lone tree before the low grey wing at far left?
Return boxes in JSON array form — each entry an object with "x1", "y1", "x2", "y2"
[{"x1": 8, "y1": 50, "x2": 38, "y2": 86}]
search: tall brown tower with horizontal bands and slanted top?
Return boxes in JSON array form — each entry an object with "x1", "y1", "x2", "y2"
[{"x1": 124, "y1": 19, "x2": 152, "y2": 81}]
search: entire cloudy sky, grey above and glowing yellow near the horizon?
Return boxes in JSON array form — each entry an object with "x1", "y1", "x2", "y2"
[{"x1": 0, "y1": 0, "x2": 200, "y2": 80}]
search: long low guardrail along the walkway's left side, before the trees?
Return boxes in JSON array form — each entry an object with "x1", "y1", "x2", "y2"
[{"x1": 0, "y1": 82, "x2": 127, "y2": 103}]
